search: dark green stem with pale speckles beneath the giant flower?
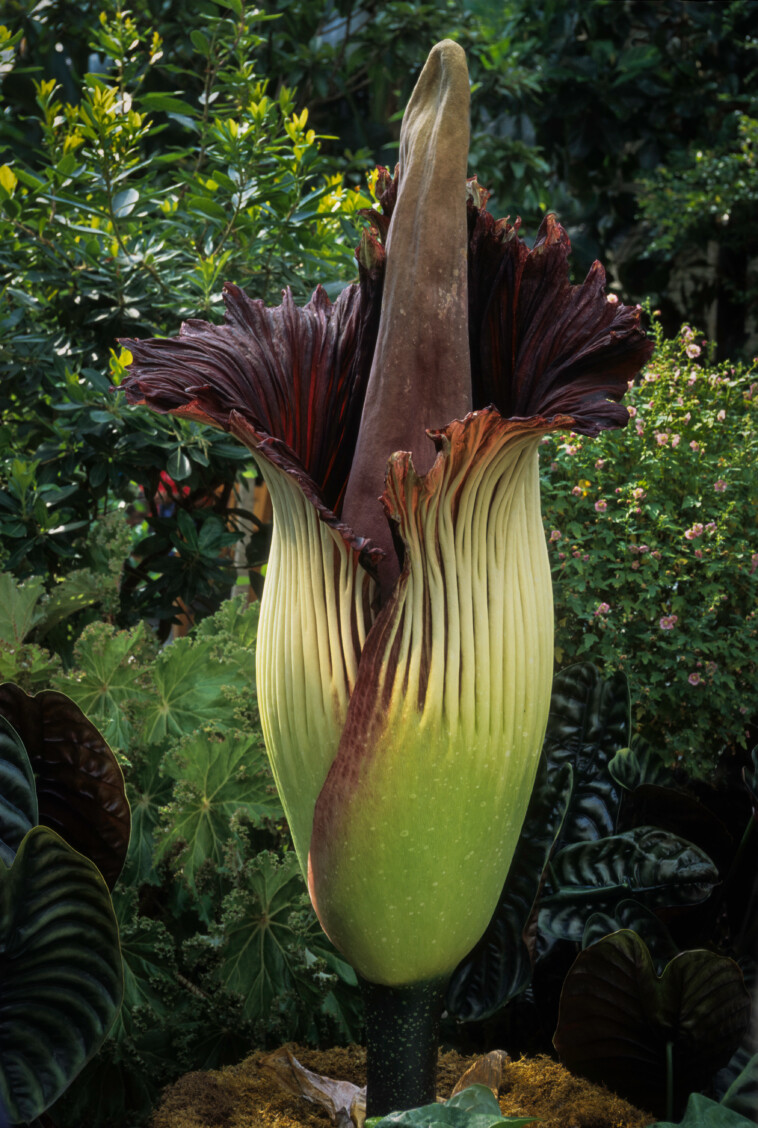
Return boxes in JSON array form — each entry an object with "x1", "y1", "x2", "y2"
[{"x1": 359, "y1": 977, "x2": 448, "y2": 1117}]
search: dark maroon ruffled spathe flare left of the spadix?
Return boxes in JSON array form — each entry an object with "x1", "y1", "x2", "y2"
[{"x1": 121, "y1": 278, "x2": 384, "y2": 571}]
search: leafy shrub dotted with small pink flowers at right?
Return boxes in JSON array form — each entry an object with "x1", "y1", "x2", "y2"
[{"x1": 543, "y1": 313, "x2": 758, "y2": 776}]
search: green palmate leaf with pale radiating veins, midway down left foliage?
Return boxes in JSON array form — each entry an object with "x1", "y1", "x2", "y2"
[{"x1": 155, "y1": 731, "x2": 282, "y2": 887}]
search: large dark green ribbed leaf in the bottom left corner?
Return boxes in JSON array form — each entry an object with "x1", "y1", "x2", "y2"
[{"x1": 0, "y1": 827, "x2": 123, "y2": 1123}]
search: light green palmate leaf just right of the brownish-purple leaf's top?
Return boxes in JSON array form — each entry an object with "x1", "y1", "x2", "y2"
[{"x1": 52, "y1": 623, "x2": 148, "y2": 748}]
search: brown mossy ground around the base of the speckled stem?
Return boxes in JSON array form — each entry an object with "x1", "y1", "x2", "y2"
[{"x1": 151, "y1": 1045, "x2": 655, "y2": 1128}]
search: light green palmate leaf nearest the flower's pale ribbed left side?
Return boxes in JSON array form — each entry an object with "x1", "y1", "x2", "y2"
[{"x1": 141, "y1": 637, "x2": 242, "y2": 743}]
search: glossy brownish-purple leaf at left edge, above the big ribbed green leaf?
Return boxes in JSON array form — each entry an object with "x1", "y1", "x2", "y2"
[{"x1": 0, "y1": 682, "x2": 131, "y2": 889}]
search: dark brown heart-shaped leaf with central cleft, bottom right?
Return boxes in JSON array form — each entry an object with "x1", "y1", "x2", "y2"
[{"x1": 554, "y1": 929, "x2": 750, "y2": 1116}]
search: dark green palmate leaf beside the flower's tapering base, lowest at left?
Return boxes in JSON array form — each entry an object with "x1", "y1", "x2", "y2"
[{"x1": 218, "y1": 853, "x2": 313, "y2": 1020}]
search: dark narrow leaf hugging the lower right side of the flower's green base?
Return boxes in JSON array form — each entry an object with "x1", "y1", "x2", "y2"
[{"x1": 446, "y1": 759, "x2": 572, "y2": 1022}]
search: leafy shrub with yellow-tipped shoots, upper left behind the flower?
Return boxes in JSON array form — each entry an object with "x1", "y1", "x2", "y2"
[{"x1": 0, "y1": 0, "x2": 369, "y2": 631}]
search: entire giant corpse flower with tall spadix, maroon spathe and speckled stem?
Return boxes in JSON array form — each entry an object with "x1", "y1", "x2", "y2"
[{"x1": 123, "y1": 41, "x2": 651, "y2": 1114}]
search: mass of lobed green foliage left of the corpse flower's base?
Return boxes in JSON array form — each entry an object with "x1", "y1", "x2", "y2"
[{"x1": 35, "y1": 600, "x2": 360, "y2": 1126}]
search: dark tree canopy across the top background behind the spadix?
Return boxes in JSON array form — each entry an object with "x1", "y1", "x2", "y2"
[{"x1": 2, "y1": 0, "x2": 758, "y2": 356}]
